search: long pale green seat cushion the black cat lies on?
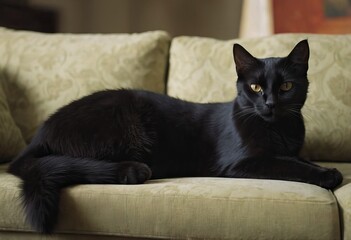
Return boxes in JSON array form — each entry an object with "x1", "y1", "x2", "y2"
[{"x1": 0, "y1": 167, "x2": 340, "y2": 240}]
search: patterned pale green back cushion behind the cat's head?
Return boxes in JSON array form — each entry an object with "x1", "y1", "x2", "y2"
[{"x1": 167, "y1": 34, "x2": 351, "y2": 161}]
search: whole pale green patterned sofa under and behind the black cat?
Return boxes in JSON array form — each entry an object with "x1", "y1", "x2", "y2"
[{"x1": 0, "y1": 28, "x2": 351, "y2": 240}]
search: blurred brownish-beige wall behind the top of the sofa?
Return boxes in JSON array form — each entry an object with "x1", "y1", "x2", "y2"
[{"x1": 29, "y1": 0, "x2": 242, "y2": 39}]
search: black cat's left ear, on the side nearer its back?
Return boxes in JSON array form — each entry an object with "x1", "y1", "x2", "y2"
[{"x1": 233, "y1": 43, "x2": 257, "y2": 74}]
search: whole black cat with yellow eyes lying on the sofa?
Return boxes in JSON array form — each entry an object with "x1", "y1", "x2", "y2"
[{"x1": 8, "y1": 40, "x2": 342, "y2": 233}]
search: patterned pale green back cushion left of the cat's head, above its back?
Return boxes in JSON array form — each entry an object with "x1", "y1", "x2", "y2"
[{"x1": 0, "y1": 28, "x2": 170, "y2": 141}]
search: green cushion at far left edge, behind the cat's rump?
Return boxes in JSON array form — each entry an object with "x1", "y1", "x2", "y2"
[{"x1": 0, "y1": 83, "x2": 25, "y2": 163}]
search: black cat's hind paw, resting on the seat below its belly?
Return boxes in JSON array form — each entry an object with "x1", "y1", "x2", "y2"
[{"x1": 117, "y1": 162, "x2": 151, "y2": 184}]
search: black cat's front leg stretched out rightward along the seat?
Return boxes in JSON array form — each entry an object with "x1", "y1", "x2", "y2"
[{"x1": 225, "y1": 157, "x2": 343, "y2": 189}]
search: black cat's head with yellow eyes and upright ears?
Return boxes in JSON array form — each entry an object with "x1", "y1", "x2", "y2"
[{"x1": 233, "y1": 40, "x2": 309, "y2": 122}]
